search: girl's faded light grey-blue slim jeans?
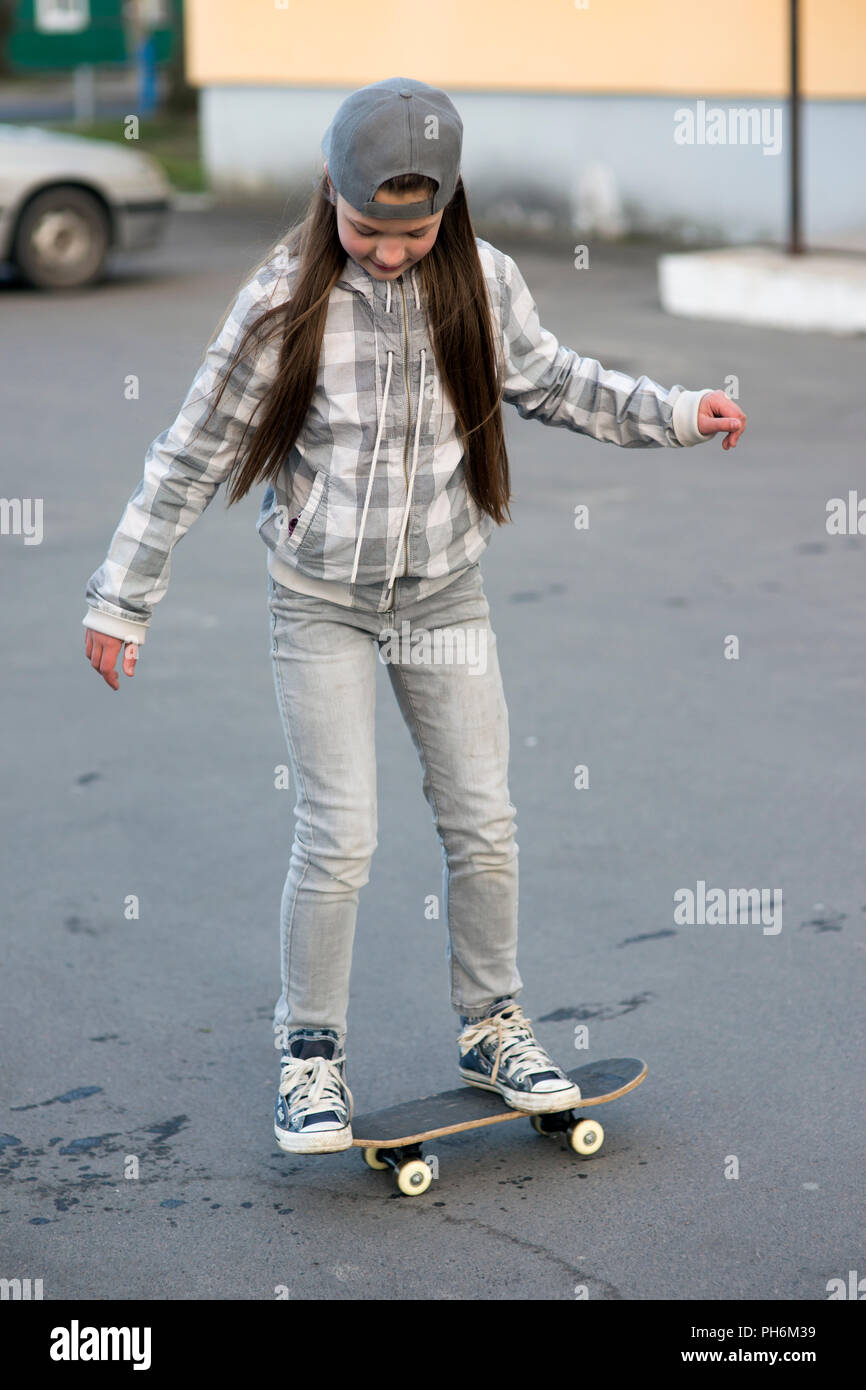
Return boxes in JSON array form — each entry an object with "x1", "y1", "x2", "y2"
[{"x1": 268, "y1": 563, "x2": 523, "y2": 1047}]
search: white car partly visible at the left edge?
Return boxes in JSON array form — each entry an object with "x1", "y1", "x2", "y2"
[{"x1": 0, "y1": 122, "x2": 172, "y2": 289}]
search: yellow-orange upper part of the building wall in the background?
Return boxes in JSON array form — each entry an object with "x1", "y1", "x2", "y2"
[{"x1": 186, "y1": 0, "x2": 866, "y2": 97}]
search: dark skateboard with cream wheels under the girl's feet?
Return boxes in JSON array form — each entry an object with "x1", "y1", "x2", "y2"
[{"x1": 352, "y1": 1056, "x2": 648, "y2": 1197}]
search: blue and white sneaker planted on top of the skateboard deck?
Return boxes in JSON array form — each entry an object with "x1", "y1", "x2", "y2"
[{"x1": 457, "y1": 999, "x2": 581, "y2": 1115}]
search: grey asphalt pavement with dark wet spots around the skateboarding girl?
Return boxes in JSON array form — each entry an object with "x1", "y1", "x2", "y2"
[{"x1": 0, "y1": 209, "x2": 866, "y2": 1301}]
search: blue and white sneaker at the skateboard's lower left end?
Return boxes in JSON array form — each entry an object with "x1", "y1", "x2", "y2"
[{"x1": 274, "y1": 1029, "x2": 353, "y2": 1154}]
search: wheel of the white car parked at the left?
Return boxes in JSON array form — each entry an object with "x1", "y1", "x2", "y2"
[{"x1": 13, "y1": 186, "x2": 111, "y2": 289}]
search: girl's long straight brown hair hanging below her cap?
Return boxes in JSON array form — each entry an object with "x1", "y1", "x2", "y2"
[{"x1": 206, "y1": 174, "x2": 512, "y2": 525}]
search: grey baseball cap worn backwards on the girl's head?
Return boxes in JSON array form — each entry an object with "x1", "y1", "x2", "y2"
[{"x1": 321, "y1": 78, "x2": 463, "y2": 218}]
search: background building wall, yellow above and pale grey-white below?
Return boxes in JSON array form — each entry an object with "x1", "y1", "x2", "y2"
[{"x1": 188, "y1": 0, "x2": 866, "y2": 243}]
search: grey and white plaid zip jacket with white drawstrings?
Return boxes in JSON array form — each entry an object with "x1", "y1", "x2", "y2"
[{"x1": 83, "y1": 238, "x2": 712, "y2": 644}]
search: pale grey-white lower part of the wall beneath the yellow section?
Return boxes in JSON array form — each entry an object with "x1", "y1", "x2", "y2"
[{"x1": 200, "y1": 86, "x2": 866, "y2": 243}]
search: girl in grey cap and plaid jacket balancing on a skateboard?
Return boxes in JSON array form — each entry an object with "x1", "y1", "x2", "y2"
[{"x1": 83, "y1": 78, "x2": 745, "y2": 1154}]
